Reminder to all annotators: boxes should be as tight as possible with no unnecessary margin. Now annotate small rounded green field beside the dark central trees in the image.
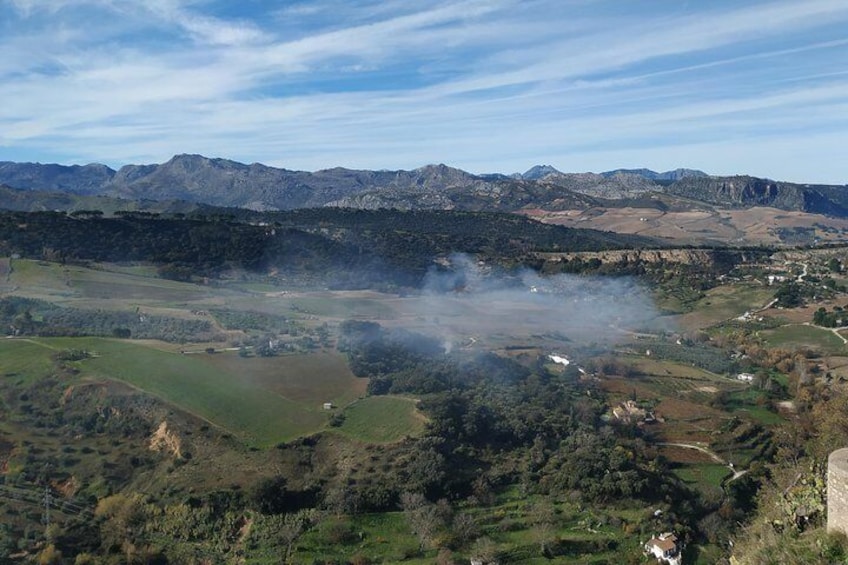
[332,396,425,443]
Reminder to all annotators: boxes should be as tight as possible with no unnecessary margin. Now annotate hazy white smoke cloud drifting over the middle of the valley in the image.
[408,255,663,346]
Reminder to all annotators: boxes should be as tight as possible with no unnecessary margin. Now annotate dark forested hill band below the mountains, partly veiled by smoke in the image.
[0,209,653,288]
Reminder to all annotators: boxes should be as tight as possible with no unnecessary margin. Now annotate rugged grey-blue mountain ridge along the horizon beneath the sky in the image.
[0,155,848,217]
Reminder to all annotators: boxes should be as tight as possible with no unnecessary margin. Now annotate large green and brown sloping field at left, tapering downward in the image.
[0,338,365,447]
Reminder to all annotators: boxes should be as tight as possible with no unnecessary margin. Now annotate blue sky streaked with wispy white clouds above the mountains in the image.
[0,0,848,184]
